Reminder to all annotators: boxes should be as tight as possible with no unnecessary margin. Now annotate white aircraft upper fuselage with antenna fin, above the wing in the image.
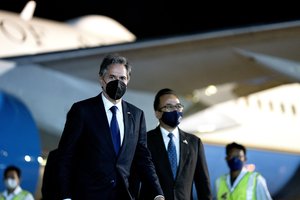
[0,1,136,58]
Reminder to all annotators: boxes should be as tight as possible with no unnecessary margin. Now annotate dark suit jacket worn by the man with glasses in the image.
[140,127,212,200]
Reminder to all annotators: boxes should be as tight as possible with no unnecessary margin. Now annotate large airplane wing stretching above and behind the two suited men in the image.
[9,21,300,103]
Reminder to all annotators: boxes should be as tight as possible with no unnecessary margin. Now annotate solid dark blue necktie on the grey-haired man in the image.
[110,106,121,154]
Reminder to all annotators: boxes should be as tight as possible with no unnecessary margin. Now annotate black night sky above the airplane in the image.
[0,0,300,39]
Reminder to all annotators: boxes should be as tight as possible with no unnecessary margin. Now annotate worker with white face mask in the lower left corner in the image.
[0,166,34,200]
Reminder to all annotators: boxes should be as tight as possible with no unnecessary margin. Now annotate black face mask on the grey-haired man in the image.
[106,80,127,100]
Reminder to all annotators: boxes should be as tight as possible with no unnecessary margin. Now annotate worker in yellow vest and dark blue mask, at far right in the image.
[216,142,272,200]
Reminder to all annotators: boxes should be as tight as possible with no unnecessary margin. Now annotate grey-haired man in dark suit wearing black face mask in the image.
[58,55,164,200]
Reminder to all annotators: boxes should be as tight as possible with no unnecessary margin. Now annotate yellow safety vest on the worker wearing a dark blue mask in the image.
[217,172,259,200]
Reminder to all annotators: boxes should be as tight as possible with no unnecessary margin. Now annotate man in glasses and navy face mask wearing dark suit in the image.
[139,88,212,200]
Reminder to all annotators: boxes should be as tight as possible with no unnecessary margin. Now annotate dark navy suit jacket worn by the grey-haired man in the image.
[58,94,163,200]
